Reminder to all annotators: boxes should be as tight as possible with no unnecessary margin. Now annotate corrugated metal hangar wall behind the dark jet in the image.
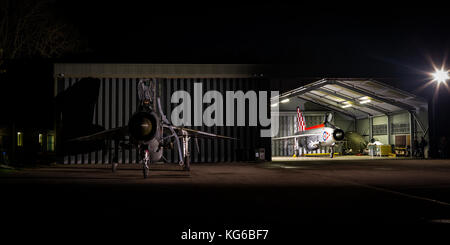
[56,77,271,164]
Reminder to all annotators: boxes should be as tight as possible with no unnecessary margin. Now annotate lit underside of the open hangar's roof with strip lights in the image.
[272,78,428,118]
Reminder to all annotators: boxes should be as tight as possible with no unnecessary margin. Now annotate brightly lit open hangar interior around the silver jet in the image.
[272,78,429,159]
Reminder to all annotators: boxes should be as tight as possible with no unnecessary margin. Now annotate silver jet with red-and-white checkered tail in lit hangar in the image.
[273,107,344,158]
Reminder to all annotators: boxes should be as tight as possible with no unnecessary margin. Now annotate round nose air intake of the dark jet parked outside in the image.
[128,112,159,141]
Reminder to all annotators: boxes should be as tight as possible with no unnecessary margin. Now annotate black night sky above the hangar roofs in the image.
[3,0,450,134]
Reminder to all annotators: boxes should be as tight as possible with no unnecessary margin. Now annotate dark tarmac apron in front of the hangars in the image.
[0,157,450,240]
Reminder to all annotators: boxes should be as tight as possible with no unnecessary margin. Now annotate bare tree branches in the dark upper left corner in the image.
[0,0,80,66]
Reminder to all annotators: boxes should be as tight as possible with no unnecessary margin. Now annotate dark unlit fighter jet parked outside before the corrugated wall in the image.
[69,79,236,178]
